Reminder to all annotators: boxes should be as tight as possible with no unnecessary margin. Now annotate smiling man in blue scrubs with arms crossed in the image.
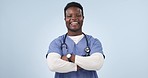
[47,2,104,78]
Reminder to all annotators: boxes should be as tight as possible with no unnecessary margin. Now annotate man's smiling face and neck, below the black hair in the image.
[65,7,84,34]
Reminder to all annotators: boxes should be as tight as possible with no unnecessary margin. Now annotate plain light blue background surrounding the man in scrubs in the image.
[0,0,148,78]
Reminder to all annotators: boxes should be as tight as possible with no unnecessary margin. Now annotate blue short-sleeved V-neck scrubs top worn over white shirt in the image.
[48,34,103,78]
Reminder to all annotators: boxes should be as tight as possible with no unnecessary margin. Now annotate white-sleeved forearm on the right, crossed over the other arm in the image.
[75,53,104,70]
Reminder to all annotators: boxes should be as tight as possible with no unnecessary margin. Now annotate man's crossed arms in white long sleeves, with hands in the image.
[47,52,104,73]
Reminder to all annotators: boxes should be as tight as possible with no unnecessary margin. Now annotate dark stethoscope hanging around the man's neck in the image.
[61,33,91,56]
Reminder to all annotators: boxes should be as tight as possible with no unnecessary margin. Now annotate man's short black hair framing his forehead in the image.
[64,2,84,17]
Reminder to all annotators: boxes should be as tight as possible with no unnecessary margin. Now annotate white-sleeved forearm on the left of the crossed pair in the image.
[47,53,77,73]
